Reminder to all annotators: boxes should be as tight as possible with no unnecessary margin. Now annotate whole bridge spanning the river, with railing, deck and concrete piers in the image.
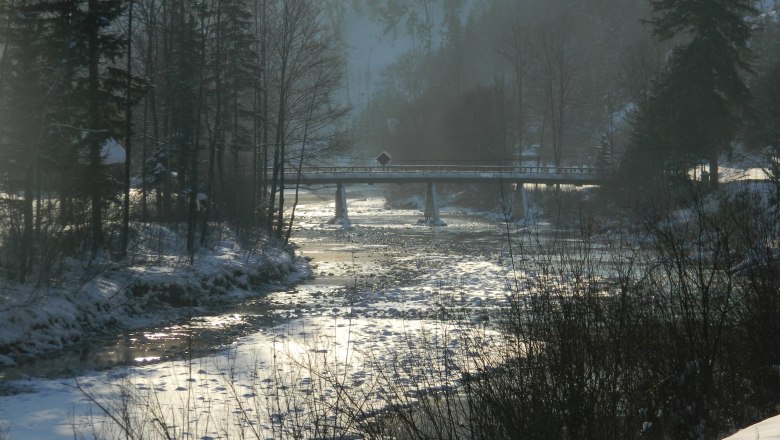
[269,165,614,227]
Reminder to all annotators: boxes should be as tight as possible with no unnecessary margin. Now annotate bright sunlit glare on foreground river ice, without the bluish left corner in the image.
[62,318,501,438]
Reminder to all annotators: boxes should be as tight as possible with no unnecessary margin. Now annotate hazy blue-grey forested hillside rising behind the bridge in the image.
[345,0,778,172]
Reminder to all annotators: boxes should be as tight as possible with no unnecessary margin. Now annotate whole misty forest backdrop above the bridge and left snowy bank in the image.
[0,0,779,251]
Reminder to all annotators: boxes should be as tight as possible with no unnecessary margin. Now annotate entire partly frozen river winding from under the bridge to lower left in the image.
[0,187,556,439]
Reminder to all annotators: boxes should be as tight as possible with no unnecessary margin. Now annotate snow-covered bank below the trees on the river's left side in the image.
[0,225,309,367]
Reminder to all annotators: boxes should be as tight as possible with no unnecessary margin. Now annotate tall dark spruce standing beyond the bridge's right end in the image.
[649,0,755,184]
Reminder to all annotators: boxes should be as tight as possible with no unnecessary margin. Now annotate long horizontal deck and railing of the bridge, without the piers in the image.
[269,165,613,185]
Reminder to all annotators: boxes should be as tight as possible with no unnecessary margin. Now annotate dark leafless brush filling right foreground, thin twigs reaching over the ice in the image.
[71,182,780,440]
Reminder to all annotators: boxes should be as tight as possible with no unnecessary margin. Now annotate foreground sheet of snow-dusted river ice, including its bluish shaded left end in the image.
[0,317,500,440]
